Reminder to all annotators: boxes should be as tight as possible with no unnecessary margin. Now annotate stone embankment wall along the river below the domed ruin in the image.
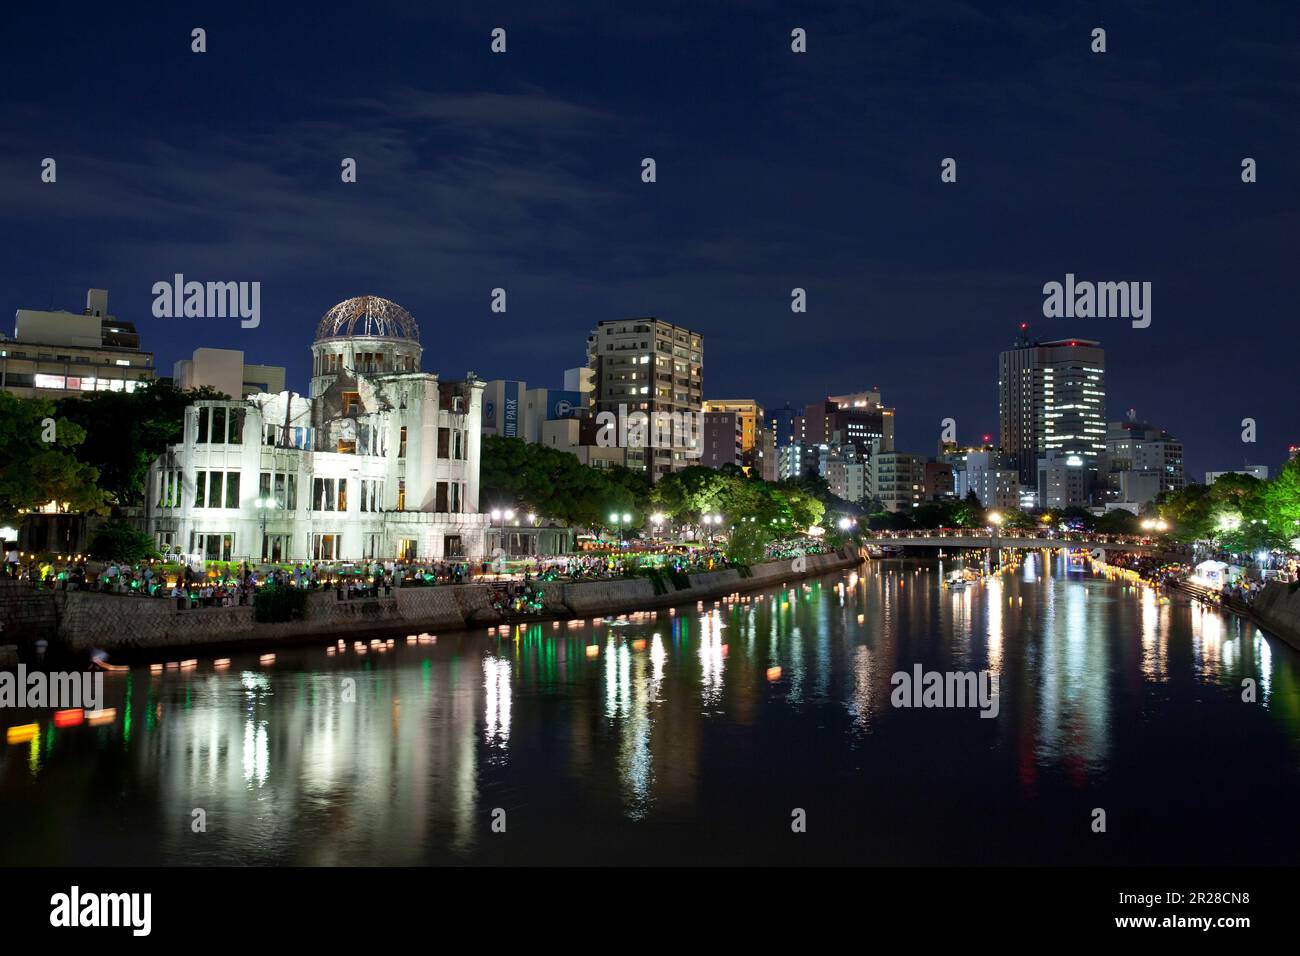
[0,546,861,656]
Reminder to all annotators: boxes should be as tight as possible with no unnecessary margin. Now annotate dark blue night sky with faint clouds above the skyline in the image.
[0,3,1300,479]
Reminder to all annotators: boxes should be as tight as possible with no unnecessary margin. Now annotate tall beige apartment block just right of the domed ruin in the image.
[586,317,705,479]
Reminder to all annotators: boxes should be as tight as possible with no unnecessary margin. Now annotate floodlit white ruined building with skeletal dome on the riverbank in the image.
[146,295,489,561]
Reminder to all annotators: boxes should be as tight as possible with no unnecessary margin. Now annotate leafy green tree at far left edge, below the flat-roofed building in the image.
[0,392,105,520]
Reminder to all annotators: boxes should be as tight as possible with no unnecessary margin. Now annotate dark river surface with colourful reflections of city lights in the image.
[0,554,1300,864]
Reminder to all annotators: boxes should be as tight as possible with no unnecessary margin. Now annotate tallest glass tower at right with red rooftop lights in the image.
[997,334,1106,492]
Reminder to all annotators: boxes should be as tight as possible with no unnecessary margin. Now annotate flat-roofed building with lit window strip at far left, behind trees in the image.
[0,289,153,398]
